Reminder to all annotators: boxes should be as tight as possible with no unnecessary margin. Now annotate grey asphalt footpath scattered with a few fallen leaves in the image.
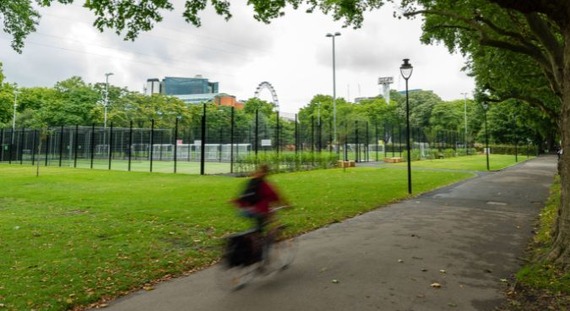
[97,156,556,311]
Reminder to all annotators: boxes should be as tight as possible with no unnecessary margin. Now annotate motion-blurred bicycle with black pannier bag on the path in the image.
[217,206,297,290]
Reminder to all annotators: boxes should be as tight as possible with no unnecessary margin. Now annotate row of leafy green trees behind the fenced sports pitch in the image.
[0,66,556,148]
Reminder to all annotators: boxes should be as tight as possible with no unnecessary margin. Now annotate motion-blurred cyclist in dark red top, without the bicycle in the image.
[234,164,288,232]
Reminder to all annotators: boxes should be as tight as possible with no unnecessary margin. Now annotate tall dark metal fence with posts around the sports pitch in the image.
[0,109,480,174]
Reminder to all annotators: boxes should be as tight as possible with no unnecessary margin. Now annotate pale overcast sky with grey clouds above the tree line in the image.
[0,0,474,112]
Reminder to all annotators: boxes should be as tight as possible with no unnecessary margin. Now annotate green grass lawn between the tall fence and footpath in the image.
[0,157,524,310]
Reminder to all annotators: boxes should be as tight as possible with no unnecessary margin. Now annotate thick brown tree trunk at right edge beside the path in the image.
[548,26,570,271]
